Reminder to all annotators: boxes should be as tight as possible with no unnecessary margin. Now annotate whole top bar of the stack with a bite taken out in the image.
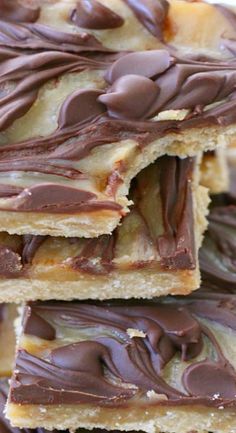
[0,0,236,237]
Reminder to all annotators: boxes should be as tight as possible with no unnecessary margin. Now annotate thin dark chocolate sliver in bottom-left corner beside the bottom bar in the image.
[0,379,69,433]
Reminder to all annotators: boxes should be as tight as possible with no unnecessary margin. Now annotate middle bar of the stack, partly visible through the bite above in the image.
[0,156,209,302]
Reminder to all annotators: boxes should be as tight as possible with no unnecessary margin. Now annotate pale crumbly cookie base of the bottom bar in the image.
[7,403,236,433]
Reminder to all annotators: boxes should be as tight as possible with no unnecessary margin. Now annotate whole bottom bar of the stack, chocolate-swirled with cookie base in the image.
[7,292,236,433]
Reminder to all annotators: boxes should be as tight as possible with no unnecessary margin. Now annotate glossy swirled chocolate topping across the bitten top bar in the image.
[0,0,236,215]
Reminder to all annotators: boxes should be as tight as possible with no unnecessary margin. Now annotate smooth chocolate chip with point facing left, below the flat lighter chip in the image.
[98,75,159,119]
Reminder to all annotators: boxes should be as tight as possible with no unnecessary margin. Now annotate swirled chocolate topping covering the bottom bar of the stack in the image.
[10,292,236,407]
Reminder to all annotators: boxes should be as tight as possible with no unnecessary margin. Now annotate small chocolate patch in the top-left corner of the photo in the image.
[0,0,40,23]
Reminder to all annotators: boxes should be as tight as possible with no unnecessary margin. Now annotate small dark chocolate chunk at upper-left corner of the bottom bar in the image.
[23,306,56,341]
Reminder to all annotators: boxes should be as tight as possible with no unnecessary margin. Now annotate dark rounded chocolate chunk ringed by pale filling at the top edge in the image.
[71,0,124,30]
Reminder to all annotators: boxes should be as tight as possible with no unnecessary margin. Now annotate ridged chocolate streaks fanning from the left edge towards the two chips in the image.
[0,21,112,131]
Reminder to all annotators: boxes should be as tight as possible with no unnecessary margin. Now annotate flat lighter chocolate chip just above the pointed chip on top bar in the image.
[105,50,173,84]
